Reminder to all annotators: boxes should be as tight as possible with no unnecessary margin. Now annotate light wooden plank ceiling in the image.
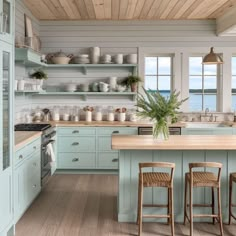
[23,0,236,20]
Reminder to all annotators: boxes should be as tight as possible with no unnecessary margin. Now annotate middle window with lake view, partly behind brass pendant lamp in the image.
[189,56,217,111]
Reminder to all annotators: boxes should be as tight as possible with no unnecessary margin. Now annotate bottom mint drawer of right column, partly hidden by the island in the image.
[98,152,119,169]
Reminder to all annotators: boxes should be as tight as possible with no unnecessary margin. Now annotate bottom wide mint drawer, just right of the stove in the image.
[58,153,96,169]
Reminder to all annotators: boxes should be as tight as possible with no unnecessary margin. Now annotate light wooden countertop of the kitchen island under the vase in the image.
[112,135,236,150]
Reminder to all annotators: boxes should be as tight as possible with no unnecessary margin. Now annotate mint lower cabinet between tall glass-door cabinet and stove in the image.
[14,138,41,223]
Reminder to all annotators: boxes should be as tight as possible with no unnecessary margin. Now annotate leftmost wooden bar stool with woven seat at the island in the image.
[137,162,175,236]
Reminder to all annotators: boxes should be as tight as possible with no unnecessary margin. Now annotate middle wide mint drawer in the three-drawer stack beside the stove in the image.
[58,136,96,152]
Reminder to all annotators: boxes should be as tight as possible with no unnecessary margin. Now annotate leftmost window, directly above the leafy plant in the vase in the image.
[145,55,173,96]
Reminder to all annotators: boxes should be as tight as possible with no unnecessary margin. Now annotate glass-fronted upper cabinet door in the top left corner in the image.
[0,0,14,44]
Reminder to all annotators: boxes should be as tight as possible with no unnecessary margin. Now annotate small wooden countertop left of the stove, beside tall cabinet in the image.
[15,131,42,150]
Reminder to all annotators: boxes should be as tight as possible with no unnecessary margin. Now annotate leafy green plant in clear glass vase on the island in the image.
[136,88,188,139]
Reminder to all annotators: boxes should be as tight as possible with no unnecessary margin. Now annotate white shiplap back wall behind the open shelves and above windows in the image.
[16,0,236,121]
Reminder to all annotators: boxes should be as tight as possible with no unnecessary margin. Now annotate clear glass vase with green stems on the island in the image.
[152,118,169,140]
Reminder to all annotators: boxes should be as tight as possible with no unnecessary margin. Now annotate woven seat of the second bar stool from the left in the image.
[186,171,219,187]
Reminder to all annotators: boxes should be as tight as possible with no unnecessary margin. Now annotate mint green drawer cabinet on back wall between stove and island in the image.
[57,127,138,170]
